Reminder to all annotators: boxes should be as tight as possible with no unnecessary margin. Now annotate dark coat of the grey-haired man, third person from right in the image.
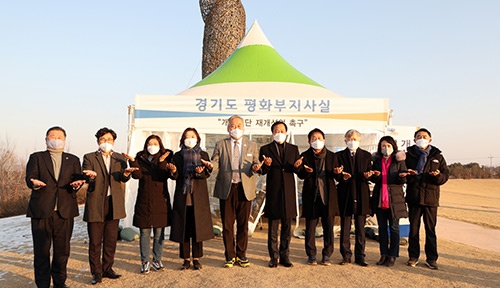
[336,148,372,216]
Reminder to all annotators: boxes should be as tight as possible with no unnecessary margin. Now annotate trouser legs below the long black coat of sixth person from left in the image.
[267,218,292,260]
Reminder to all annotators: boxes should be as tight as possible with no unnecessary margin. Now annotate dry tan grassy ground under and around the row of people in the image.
[0,180,500,288]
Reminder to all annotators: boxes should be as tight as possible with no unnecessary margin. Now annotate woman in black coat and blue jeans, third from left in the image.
[125,135,177,274]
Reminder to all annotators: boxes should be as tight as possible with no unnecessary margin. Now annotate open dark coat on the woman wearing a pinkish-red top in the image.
[370,155,408,219]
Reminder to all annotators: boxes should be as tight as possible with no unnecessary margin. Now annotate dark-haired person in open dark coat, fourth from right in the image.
[297,128,342,266]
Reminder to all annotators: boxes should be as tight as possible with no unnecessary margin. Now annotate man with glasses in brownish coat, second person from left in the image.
[83,128,138,285]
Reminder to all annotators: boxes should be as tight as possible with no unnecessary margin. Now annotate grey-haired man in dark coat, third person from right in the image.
[336,129,373,267]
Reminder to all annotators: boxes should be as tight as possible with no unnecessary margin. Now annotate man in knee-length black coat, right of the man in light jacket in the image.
[259,121,301,268]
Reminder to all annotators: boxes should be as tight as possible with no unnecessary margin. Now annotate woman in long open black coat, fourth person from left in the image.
[170,128,214,270]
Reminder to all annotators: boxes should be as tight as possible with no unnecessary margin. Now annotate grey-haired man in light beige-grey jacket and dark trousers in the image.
[212,115,260,268]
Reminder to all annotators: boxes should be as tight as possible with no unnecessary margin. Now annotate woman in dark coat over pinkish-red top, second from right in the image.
[370,136,408,267]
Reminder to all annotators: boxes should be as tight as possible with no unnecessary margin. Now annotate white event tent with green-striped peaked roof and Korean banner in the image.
[124,22,415,230]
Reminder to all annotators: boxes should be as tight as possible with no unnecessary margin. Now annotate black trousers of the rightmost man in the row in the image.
[408,205,438,261]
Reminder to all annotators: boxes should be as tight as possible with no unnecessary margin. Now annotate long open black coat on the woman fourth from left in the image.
[170,151,214,243]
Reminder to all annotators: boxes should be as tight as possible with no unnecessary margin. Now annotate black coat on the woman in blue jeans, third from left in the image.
[130,150,177,228]
